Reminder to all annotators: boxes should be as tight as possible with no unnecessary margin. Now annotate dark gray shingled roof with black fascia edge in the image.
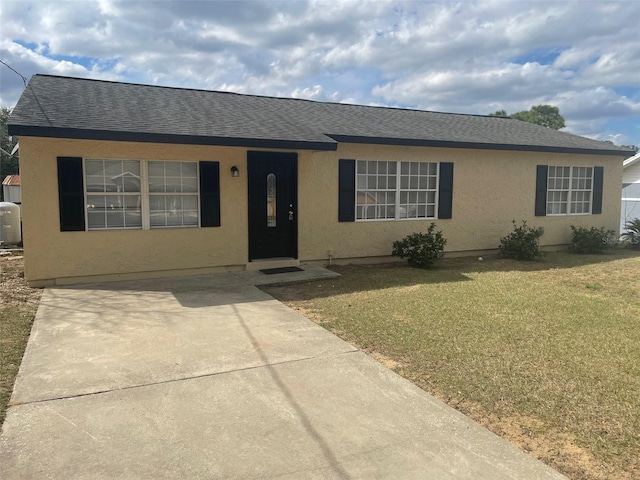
[9,75,633,157]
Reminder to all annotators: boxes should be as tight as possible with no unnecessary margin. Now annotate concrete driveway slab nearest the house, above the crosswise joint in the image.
[11,285,354,405]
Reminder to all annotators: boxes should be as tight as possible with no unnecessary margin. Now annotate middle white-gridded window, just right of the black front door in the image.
[356,160,438,220]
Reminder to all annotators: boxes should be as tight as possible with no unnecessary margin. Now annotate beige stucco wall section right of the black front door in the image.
[299,144,622,260]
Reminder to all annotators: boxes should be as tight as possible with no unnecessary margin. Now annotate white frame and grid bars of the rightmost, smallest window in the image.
[545,165,595,217]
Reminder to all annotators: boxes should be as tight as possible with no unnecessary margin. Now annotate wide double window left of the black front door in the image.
[84,160,199,230]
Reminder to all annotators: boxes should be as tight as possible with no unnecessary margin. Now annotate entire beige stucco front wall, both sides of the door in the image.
[20,137,622,284]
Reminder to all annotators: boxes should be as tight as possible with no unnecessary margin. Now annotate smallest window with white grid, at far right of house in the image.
[547,166,593,215]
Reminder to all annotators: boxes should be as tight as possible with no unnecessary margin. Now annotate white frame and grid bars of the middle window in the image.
[354,160,440,222]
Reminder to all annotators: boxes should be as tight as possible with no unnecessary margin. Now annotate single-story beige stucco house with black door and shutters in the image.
[9,75,632,286]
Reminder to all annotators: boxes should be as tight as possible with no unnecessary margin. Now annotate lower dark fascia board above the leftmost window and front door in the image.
[9,124,338,151]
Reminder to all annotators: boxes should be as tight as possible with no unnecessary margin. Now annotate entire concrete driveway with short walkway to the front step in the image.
[0,266,565,480]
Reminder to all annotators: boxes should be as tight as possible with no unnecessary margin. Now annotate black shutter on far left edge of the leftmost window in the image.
[58,157,85,232]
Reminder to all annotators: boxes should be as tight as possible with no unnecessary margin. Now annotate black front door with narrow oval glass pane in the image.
[247,152,298,260]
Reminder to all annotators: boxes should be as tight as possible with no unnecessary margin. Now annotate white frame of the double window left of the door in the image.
[82,158,201,232]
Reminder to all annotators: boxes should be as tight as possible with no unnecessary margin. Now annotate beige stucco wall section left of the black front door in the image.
[20,137,248,282]
